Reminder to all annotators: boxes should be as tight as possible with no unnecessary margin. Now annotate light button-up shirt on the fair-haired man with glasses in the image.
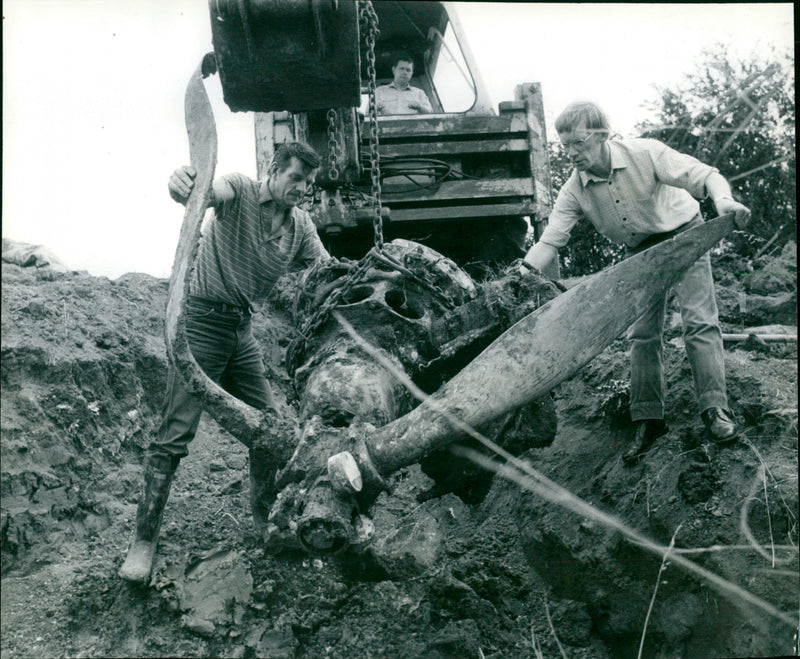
[540,138,717,248]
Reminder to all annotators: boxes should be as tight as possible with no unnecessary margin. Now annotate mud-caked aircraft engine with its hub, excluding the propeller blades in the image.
[260,240,557,551]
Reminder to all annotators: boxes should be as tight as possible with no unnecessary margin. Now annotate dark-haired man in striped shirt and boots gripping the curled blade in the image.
[120,142,330,583]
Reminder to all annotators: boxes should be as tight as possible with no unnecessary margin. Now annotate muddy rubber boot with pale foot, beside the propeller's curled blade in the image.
[119,456,178,584]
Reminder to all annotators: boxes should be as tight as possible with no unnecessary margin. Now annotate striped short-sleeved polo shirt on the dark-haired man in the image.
[189,174,330,306]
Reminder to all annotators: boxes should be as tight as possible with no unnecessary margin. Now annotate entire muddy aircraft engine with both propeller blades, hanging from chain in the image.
[166,51,733,551]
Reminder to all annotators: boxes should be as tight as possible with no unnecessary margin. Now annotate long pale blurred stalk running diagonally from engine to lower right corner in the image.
[332,311,796,629]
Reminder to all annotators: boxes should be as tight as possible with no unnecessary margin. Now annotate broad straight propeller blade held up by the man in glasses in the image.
[367,214,734,473]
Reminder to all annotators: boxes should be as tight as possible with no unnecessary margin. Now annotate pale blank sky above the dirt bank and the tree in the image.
[2,0,794,278]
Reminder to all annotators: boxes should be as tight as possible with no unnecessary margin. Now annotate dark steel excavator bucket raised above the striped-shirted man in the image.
[209,0,361,112]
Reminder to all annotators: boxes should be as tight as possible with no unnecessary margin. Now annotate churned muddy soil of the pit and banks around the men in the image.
[0,245,800,659]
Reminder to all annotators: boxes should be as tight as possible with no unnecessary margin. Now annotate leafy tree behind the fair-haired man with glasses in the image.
[550,44,797,276]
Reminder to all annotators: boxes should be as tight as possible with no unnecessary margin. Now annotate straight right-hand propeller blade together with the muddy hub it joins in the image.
[262,216,733,550]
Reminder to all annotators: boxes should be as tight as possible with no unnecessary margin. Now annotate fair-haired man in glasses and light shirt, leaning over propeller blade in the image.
[524,102,750,464]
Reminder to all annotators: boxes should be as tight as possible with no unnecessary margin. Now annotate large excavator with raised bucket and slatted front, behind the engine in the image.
[209,0,552,275]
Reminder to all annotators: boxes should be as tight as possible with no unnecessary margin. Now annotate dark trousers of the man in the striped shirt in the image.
[149,297,273,462]
